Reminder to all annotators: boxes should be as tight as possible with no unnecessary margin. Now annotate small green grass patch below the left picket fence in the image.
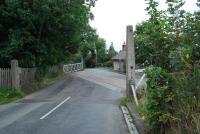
[0,88,25,105]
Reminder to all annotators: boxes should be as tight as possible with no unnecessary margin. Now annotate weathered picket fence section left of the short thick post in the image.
[0,68,12,88]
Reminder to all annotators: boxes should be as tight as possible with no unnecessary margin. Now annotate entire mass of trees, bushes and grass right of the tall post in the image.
[134,0,200,134]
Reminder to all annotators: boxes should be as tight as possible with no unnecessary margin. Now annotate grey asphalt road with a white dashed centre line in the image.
[0,69,128,134]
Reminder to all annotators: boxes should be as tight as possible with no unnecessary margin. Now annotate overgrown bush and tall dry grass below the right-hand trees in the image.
[145,65,200,134]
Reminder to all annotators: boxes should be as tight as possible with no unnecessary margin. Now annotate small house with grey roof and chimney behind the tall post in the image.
[112,43,126,73]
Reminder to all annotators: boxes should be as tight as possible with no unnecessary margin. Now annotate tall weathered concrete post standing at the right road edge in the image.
[126,26,135,97]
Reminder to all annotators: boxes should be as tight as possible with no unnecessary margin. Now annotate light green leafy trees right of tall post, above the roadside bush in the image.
[134,0,200,71]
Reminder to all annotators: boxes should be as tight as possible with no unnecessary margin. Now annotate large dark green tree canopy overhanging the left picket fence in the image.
[0,0,95,67]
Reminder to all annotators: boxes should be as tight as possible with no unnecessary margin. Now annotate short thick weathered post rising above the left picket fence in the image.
[11,60,20,90]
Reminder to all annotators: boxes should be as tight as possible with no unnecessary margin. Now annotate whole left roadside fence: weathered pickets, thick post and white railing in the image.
[0,60,83,89]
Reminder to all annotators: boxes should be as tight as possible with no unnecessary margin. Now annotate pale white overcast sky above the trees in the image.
[90,0,197,51]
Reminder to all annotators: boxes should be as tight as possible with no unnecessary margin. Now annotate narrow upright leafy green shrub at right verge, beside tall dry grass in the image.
[145,66,173,134]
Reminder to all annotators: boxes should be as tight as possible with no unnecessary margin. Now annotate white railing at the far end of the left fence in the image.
[63,63,83,73]
